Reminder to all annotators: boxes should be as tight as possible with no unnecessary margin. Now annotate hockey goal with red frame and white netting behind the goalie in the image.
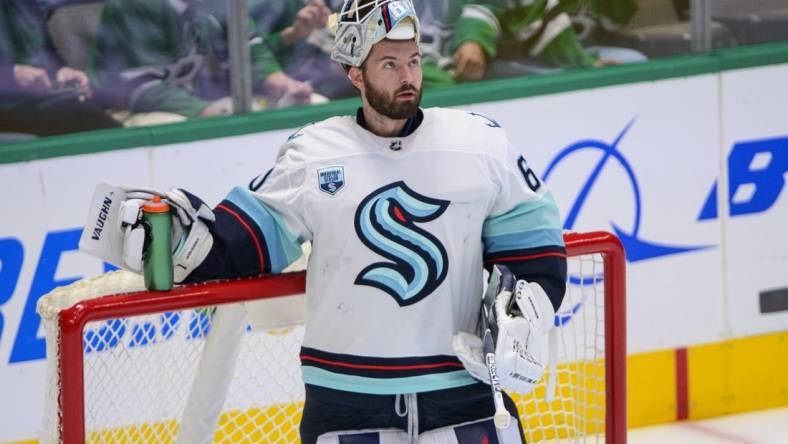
[37,232,626,444]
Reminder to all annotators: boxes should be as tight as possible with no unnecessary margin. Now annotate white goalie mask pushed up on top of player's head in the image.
[331,0,419,66]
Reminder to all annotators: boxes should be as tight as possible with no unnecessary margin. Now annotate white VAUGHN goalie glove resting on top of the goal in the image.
[79,183,215,283]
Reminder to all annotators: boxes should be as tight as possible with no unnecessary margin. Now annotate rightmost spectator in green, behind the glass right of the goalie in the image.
[492,0,646,76]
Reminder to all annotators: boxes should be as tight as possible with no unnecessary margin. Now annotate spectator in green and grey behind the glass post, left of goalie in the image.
[91,0,318,122]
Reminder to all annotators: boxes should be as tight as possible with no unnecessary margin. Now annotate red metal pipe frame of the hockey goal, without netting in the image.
[58,231,627,444]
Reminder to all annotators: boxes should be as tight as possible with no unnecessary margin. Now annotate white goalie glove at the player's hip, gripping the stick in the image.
[452,266,555,394]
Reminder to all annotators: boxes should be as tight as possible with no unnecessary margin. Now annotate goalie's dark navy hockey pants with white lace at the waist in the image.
[300,383,525,444]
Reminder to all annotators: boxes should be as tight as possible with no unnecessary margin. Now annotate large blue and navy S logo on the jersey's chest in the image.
[355,182,450,307]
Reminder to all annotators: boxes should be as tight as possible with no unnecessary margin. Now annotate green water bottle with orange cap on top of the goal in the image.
[142,196,172,291]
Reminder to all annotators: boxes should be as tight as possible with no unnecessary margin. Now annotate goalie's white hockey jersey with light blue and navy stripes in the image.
[209,108,565,394]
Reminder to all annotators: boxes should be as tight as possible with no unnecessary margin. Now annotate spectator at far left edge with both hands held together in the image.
[0,0,119,139]
